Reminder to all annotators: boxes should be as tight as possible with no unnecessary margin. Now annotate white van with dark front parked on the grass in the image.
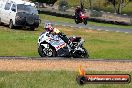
[0,0,40,30]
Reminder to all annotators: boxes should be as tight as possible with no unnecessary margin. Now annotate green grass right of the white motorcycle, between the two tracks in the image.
[60,26,132,59]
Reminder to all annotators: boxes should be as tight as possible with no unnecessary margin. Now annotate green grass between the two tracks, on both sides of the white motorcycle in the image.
[0,26,132,59]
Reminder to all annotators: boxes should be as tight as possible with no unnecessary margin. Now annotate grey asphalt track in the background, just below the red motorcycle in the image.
[43,20,132,33]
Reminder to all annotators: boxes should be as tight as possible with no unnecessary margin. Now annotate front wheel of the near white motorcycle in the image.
[38,45,56,57]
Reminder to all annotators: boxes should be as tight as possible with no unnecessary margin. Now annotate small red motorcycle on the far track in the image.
[75,12,88,25]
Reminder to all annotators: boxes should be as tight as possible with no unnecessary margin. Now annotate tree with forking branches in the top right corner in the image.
[107,0,132,14]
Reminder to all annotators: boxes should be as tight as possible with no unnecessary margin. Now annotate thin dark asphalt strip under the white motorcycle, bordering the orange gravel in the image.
[0,56,132,62]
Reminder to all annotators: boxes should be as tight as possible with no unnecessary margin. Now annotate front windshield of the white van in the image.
[17,4,38,14]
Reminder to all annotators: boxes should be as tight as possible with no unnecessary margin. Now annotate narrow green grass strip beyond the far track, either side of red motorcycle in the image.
[40,14,132,30]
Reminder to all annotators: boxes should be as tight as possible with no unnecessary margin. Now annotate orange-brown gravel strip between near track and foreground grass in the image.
[0,59,132,71]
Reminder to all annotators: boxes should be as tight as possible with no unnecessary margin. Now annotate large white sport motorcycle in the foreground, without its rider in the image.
[38,32,89,58]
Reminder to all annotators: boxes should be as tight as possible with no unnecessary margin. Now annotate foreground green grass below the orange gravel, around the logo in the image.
[0,71,132,88]
